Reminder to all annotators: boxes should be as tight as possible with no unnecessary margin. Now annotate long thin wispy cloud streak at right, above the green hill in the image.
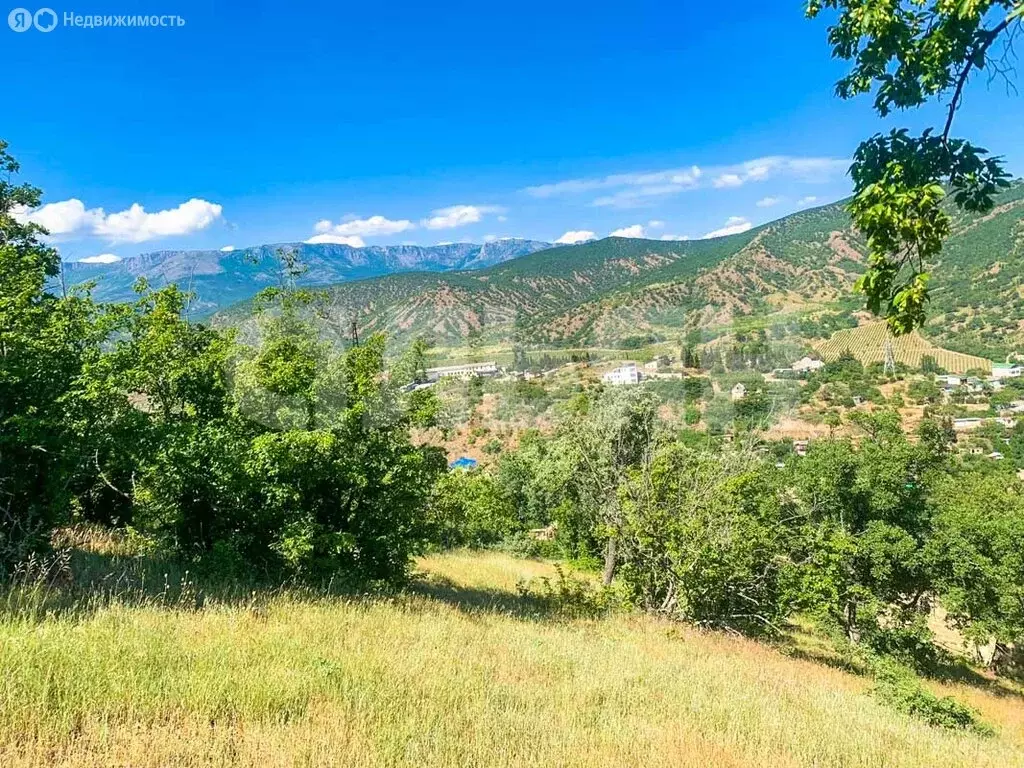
[523,155,849,208]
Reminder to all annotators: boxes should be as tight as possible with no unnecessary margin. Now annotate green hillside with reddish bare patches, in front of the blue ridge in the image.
[218,182,1024,356]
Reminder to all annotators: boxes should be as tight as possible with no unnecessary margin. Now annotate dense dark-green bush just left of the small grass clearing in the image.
[246,428,443,584]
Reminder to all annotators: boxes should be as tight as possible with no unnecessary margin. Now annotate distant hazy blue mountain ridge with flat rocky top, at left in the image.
[65,238,552,313]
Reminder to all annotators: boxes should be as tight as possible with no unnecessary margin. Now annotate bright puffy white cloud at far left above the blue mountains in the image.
[14,198,223,243]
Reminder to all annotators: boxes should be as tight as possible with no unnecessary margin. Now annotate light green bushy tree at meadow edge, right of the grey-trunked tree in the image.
[622,443,793,633]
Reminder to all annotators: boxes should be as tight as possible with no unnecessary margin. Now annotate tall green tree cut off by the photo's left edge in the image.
[0,140,105,572]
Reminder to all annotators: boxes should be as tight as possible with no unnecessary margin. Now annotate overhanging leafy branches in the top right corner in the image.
[807,0,1024,335]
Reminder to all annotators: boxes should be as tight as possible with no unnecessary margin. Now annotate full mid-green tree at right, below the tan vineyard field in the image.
[793,423,931,641]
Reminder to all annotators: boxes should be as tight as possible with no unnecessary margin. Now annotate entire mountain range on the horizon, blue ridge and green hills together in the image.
[69,181,1024,359]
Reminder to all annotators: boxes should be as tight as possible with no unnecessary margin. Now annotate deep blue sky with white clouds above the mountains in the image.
[8,0,1024,258]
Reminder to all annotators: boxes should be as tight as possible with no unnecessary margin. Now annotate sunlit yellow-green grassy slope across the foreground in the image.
[0,553,1024,768]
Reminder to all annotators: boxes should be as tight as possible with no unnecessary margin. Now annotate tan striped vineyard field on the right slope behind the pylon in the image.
[815,323,992,373]
